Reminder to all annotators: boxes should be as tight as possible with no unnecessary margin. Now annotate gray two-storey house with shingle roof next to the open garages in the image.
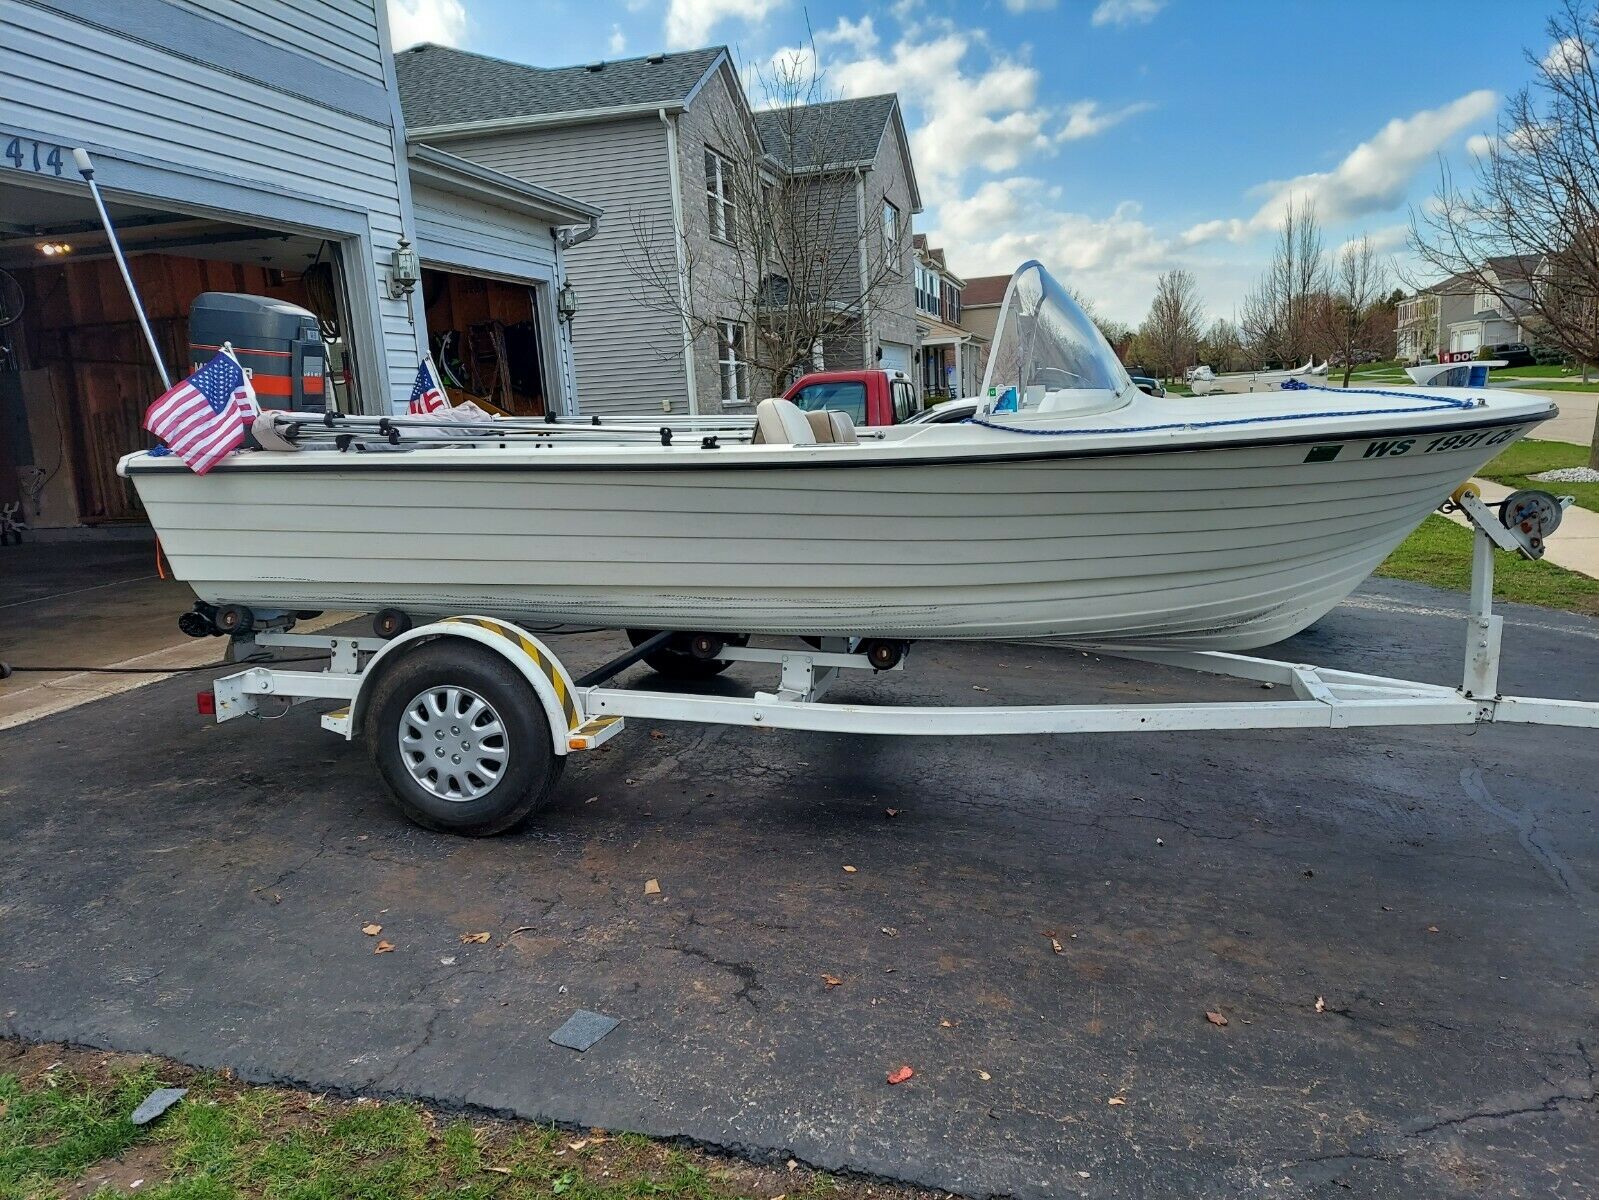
[395,45,921,413]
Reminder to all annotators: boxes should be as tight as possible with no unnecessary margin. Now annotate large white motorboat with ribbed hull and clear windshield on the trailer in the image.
[118,262,1556,650]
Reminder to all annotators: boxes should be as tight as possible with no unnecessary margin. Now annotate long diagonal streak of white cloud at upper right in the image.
[1183,90,1497,245]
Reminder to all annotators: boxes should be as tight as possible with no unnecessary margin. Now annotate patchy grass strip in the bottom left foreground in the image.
[0,1042,924,1200]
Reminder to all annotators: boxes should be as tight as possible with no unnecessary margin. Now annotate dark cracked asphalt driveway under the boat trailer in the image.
[0,582,1599,1197]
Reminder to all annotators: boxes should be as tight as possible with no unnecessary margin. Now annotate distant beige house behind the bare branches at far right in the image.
[1396,254,1543,362]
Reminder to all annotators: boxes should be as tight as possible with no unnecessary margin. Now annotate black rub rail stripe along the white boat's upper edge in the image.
[128,405,1559,475]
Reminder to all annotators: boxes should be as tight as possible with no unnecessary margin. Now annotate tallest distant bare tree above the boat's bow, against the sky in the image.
[1239,197,1327,366]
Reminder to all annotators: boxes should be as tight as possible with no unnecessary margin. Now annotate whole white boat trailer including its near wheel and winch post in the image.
[200,485,1599,835]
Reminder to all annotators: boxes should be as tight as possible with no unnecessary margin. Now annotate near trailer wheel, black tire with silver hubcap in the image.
[363,649,566,837]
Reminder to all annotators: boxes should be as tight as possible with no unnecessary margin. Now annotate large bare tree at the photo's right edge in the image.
[1410,0,1599,466]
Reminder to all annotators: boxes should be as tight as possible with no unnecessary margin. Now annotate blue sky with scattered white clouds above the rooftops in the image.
[389,0,1548,322]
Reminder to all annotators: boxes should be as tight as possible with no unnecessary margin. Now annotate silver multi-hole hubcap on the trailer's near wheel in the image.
[400,686,510,802]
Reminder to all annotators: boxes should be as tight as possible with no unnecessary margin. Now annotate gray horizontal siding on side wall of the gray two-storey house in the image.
[438,117,694,416]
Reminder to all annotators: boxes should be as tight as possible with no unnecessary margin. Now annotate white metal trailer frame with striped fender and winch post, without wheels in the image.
[211,488,1599,838]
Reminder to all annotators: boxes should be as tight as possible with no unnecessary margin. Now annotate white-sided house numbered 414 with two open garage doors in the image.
[0,0,600,528]
